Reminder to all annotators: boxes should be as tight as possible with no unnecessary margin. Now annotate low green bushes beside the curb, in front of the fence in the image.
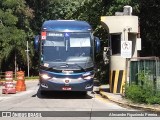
[125,70,160,104]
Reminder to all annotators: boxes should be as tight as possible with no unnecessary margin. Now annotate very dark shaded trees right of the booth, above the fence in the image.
[140,0,160,56]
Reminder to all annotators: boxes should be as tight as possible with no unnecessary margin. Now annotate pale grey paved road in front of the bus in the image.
[0,81,159,120]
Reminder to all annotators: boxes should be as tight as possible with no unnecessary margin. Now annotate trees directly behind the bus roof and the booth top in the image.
[26,0,139,79]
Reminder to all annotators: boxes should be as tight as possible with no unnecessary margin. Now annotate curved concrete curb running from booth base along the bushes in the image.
[99,89,160,112]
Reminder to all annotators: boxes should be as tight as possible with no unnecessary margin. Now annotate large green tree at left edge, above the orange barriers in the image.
[0,0,33,73]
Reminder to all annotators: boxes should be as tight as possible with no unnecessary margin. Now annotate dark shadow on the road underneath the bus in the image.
[32,90,93,99]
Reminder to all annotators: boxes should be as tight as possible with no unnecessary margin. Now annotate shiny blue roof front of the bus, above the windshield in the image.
[42,20,92,32]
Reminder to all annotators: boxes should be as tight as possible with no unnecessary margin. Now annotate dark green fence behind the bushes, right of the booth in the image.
[129,57,160,91]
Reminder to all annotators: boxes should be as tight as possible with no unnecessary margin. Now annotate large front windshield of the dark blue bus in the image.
[42,32,93,67]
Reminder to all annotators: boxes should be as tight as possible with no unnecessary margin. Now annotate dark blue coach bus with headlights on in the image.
[34,20,100,94]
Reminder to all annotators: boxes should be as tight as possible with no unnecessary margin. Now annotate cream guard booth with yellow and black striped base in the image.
[101,6,141,93]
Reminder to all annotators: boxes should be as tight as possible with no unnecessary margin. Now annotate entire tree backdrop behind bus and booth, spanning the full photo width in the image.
[0,0,160,79]
